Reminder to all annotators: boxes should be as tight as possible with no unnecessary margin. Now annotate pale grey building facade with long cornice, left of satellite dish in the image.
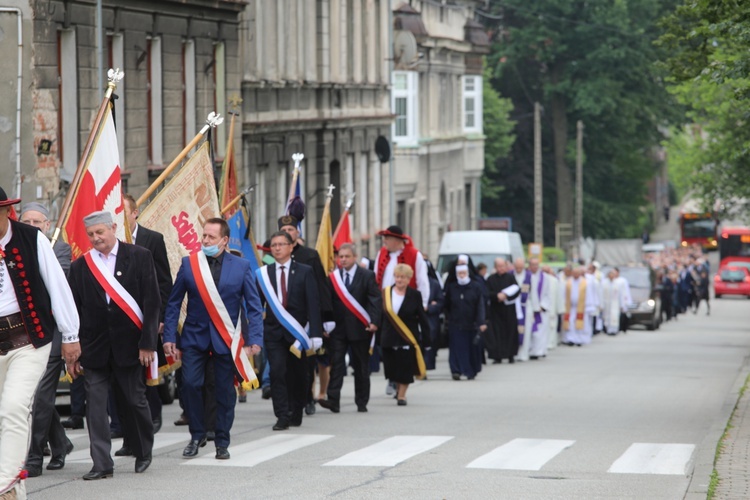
[241,0,393,255]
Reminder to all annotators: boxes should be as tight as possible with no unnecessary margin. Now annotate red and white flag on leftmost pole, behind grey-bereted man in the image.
[63,104,125,259]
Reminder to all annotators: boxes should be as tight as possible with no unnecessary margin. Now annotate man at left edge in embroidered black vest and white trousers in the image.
[0,188,81,498]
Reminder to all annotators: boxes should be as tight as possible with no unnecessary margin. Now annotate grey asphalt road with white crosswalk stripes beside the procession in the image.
[27,299,750,500]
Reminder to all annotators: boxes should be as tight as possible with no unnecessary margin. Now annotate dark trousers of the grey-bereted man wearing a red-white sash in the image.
[85,363,154,471]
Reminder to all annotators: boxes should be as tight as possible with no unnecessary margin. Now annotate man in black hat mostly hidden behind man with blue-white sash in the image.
[278,215,336,415]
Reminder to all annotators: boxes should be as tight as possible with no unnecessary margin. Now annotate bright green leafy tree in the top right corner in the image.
[659,0,750,216]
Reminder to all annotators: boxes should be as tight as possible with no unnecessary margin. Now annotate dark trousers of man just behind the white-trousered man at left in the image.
[26,332,68,467]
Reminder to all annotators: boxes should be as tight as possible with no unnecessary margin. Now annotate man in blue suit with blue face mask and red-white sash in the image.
[164,218,263,460]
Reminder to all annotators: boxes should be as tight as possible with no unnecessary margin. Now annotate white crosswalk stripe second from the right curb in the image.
[466,439,575,470]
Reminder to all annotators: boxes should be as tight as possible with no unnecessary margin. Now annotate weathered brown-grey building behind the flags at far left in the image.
[0,0,245,217]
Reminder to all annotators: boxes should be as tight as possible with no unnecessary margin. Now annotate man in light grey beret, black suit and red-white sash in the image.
[68,211,161,480]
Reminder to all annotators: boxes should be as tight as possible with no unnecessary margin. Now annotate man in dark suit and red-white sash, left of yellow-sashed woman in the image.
[318,243,382,413]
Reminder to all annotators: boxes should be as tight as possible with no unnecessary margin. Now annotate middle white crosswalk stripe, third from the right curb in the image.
[323,436,453,467]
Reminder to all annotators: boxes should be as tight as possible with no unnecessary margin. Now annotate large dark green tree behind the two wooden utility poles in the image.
[488,0,678,241]
